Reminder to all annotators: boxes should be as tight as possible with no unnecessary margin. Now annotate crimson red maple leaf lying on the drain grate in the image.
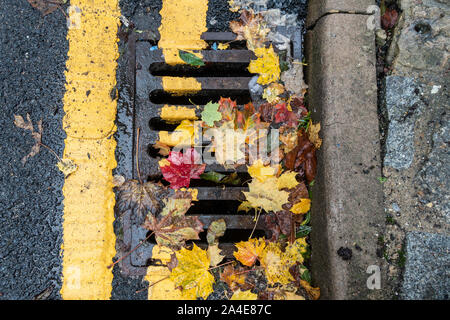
[160,148,206,189]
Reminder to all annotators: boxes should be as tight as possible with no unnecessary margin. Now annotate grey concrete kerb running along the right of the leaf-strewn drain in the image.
[305,0,385,299]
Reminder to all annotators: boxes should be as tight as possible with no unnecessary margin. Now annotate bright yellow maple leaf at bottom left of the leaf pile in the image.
[170,243,215,299]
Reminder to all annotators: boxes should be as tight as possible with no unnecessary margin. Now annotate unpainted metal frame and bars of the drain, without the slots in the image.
[121,27,302,275]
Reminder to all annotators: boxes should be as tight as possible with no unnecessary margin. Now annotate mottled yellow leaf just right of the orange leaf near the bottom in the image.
[260,242,294,285]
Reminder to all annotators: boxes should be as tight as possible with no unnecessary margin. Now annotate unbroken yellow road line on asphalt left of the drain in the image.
[61,0,120,299]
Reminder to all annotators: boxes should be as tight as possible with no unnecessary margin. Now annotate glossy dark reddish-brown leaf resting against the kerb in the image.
[285,129,317,183]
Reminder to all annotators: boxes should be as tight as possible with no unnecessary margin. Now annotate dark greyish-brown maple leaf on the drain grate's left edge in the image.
[118,180,165,218]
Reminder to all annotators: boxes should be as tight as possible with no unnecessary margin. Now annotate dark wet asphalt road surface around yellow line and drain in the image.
[0,0,306,299]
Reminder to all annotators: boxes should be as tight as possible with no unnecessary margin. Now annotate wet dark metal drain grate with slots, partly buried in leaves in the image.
[122,28,301,275]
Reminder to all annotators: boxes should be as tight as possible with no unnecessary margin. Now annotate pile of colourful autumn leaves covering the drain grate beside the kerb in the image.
[114,10,322,300]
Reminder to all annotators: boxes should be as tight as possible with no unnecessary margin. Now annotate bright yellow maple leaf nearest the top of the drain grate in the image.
[248,45,281,85]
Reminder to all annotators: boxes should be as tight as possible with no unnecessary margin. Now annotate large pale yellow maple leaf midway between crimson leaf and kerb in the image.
[243,177,289,212]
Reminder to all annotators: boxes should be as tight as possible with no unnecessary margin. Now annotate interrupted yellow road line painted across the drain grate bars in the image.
[149,0,208,300]
